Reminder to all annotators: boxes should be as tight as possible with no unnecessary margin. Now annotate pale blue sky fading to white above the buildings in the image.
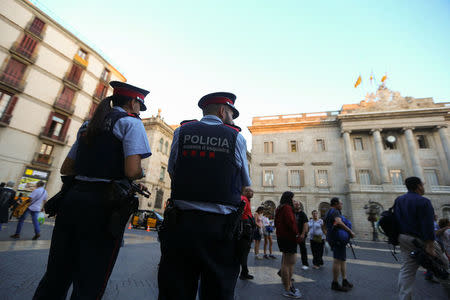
[32,0,450,148]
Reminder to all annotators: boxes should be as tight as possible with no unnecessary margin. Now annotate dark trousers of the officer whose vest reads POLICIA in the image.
[158,211,241,300]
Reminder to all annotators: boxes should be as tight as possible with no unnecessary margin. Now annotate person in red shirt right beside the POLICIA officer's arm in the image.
[239,187,255,280]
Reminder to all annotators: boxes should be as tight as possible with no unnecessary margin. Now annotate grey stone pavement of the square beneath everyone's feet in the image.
[0,221,448,300]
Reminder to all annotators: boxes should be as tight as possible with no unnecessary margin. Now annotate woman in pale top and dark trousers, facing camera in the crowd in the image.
[308,210,326,269]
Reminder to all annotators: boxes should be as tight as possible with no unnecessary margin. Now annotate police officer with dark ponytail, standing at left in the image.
[33,81,151,300]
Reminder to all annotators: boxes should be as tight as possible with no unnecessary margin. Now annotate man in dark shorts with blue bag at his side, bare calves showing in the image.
[325,197,355,292]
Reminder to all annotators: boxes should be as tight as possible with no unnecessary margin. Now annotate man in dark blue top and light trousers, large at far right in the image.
[394,177,436,299]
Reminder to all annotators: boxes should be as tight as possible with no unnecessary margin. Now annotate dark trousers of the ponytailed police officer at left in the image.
[33,182,125,300]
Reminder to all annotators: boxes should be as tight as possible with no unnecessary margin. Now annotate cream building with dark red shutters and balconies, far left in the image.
[0,0,126,195]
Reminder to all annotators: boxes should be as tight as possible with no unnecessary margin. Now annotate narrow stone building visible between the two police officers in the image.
[140,110,174,213]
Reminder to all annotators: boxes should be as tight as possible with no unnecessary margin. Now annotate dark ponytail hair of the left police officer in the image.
[86,95,131,144]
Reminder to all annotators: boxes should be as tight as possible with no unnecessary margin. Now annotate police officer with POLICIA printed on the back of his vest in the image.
[158,92,251,300]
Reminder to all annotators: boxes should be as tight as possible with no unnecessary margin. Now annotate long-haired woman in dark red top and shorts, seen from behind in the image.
[275,191,302,298]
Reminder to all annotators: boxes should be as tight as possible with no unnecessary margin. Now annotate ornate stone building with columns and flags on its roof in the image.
[249,86,450,238]
